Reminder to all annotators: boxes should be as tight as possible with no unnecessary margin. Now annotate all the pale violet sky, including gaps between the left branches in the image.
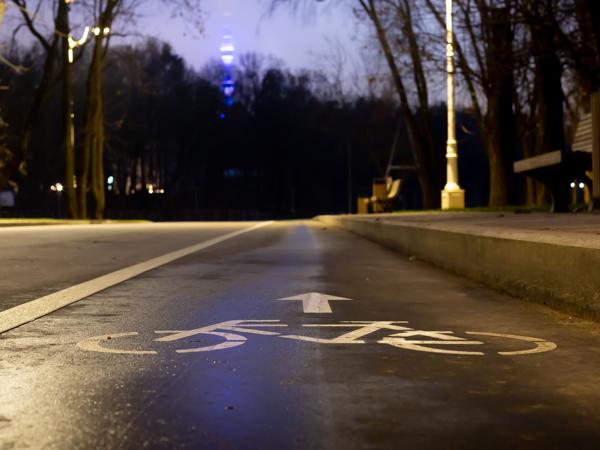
[0,0,361,78]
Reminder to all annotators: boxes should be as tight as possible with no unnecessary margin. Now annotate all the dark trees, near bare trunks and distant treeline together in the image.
[0,0,600,218]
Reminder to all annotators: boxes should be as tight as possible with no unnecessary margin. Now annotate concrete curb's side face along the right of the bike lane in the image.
[317,216,600,321]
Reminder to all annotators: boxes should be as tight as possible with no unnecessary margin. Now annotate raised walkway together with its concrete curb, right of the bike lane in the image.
[319,212,600,320]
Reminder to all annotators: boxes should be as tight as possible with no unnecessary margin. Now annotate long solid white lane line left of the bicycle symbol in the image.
[0,221,273,334]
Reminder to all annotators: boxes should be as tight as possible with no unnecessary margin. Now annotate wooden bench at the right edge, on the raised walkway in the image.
[513,114,592,212]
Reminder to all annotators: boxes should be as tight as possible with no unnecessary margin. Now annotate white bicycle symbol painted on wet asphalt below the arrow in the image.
[77,320,557,356]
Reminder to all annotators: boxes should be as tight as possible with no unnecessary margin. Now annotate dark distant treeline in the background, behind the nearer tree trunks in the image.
[0,40,487,219]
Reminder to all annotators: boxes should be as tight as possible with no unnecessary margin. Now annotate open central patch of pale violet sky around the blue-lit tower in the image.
[138,0,359,69]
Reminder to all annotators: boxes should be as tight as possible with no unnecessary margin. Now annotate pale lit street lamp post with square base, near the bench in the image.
[442,0,465,209]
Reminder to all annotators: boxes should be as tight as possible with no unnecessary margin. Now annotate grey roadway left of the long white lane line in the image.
[0,222,255,311]
